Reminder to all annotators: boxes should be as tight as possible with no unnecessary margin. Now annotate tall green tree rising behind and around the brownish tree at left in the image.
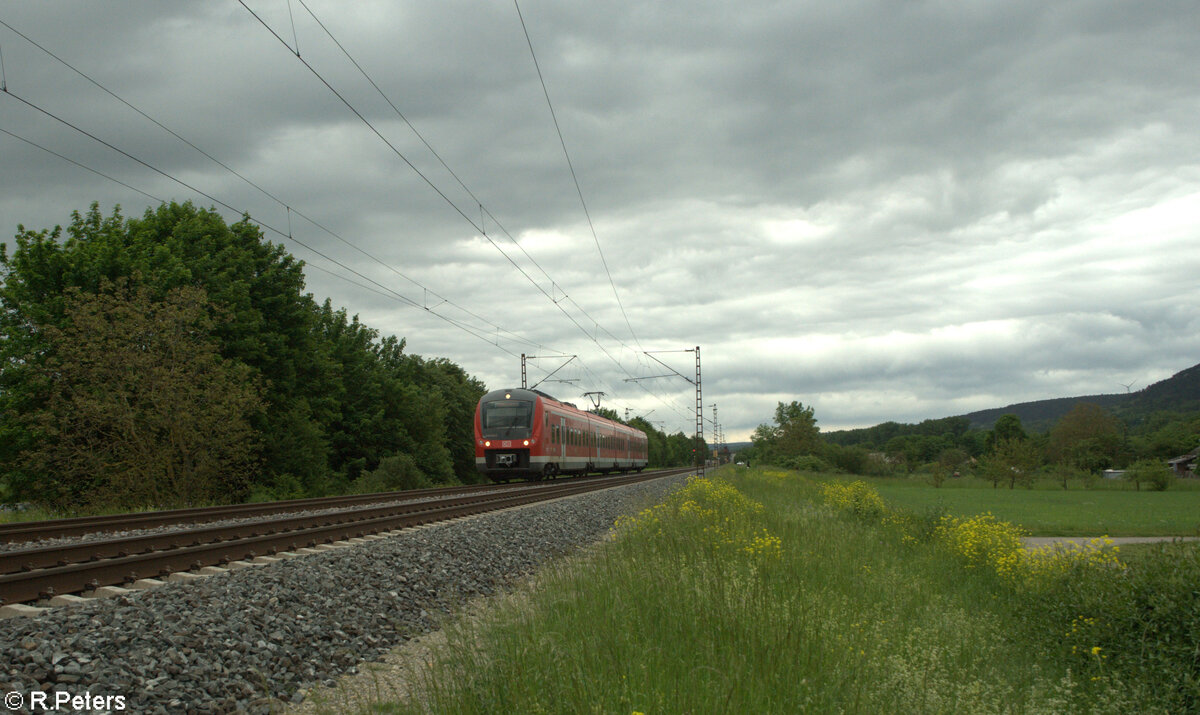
[0,203,338,491]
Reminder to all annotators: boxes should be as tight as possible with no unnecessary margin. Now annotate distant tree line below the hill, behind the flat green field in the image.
[738,393,1200,488]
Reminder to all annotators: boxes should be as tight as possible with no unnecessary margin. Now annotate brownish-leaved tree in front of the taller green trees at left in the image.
[14,281,262,509]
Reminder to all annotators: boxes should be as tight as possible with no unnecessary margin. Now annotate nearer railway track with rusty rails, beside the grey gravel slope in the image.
[0,469,690,603]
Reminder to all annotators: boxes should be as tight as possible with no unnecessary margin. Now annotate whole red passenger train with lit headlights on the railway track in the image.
[475,387,647,481]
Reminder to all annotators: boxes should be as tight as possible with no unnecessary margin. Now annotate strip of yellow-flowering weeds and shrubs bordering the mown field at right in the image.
[821,472,1200,713]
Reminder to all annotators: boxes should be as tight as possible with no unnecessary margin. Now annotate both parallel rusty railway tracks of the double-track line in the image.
[0,469,688,606]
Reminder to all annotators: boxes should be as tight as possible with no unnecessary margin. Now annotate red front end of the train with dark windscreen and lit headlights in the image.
[475,389,541,481]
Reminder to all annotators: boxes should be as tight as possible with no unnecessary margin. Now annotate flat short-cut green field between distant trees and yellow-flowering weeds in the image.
[869,479,1200,536]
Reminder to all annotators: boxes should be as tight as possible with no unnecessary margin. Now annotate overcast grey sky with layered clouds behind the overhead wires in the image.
[0,0,1200,440]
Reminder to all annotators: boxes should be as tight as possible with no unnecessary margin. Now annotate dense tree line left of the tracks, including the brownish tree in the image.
[0,203,484,509]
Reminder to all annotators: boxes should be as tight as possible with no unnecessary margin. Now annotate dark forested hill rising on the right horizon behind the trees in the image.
[961,365,1200,432]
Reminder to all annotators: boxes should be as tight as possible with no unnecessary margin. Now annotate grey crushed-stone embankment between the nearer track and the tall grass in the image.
[0,476,684,714]
